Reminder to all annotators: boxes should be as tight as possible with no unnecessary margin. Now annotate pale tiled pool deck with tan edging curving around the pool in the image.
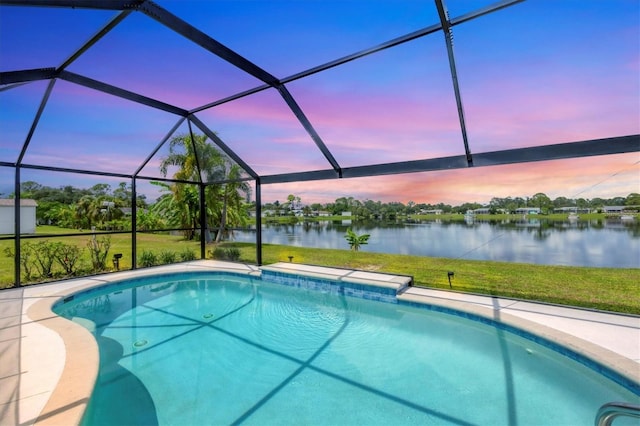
[0,261,640,425]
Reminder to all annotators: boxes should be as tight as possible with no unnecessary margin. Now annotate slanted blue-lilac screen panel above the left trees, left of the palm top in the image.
[24,81,176,174]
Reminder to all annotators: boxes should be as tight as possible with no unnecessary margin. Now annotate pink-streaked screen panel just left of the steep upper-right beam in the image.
[288,33,464,167]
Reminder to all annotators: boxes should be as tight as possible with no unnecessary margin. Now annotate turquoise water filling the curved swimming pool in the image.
[55,273,640,425]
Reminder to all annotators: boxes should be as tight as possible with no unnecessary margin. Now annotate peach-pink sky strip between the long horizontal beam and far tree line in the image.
[263,153,640,205]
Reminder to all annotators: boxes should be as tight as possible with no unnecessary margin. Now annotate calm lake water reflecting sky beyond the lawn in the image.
[234,218,640,268]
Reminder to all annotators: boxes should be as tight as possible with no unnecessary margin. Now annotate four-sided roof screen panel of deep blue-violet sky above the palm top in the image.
[69,13,262,109]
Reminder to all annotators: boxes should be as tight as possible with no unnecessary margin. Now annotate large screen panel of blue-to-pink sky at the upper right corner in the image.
[453,1,640,152]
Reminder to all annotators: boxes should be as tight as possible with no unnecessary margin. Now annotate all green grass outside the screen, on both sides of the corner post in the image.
[0,227,640,315]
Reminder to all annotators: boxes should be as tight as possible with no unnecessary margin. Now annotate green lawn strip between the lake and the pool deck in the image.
[225,243,640,315]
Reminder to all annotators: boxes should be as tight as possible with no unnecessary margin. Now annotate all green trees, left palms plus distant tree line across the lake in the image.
[6,134,640,236]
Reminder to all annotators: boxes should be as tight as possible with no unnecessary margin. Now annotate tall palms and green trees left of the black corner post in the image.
[10,135,251,241]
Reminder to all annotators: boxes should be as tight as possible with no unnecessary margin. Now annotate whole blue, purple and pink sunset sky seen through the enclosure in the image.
[0,0,640,205]
